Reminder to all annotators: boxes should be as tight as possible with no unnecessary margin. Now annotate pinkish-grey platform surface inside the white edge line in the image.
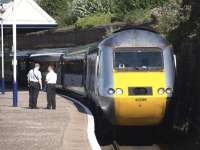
[0,92,91,150]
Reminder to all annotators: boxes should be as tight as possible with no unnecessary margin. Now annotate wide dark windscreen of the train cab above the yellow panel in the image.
[114,49,163,70]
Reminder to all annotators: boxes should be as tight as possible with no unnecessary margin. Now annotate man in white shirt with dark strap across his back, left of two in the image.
[27,63,42,109]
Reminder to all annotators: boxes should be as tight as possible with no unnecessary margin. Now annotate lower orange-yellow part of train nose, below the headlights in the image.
[115,96,166,125]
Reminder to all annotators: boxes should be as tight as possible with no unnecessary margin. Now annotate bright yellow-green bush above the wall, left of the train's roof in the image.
[75,13,111,29]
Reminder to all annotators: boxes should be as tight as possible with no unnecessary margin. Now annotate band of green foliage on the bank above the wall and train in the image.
[40,0,190,34]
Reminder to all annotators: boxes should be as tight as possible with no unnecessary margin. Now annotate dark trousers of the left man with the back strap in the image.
[29,82,40,108]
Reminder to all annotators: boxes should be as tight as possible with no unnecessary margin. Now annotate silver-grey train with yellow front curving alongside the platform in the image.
[28,29,175,126]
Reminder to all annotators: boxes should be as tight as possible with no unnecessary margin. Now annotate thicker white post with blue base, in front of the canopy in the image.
[13,0,18,107]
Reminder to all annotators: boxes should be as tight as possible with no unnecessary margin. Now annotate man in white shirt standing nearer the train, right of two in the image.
[46,65,57,109]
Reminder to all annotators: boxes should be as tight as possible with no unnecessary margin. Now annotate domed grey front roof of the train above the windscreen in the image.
[99,29,171,49]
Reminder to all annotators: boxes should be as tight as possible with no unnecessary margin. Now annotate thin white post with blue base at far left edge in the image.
[0,3,6,94]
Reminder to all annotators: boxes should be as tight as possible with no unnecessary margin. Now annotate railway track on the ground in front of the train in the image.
[102,141,163,150]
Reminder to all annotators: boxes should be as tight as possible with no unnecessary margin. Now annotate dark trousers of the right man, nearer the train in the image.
[47,84,56,109]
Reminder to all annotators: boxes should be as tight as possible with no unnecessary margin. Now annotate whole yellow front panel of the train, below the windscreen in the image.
[114,72,167,125]
